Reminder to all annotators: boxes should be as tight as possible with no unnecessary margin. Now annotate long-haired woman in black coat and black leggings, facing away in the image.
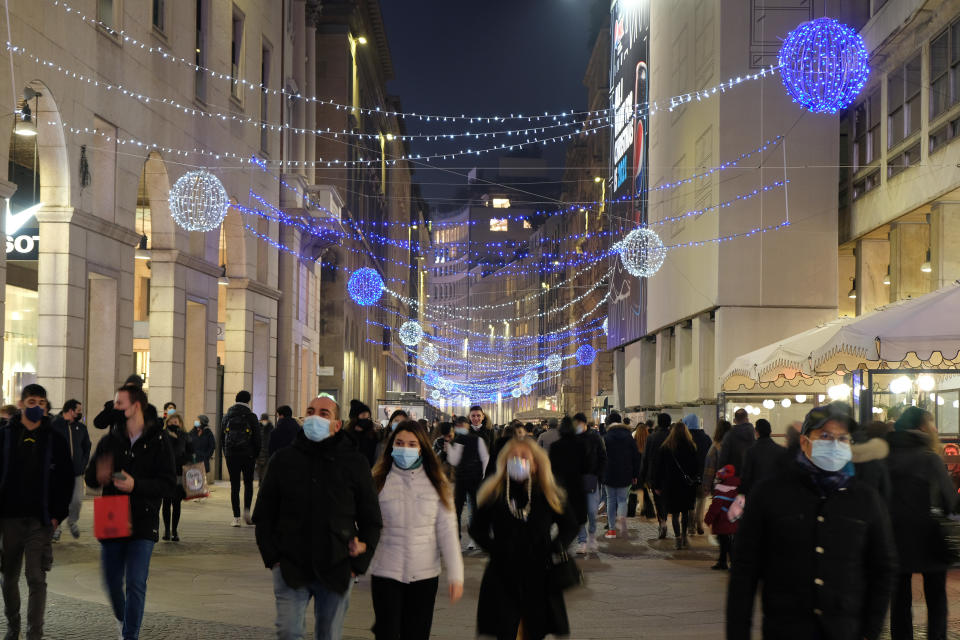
[653,422,701,549]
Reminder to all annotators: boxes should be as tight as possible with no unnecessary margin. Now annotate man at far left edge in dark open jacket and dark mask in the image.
[0,384,73,640]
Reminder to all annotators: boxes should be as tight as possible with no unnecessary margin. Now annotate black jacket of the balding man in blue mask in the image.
[253,431,383,593]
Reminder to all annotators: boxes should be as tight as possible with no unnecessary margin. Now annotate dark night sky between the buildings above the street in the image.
[380,0,609,209]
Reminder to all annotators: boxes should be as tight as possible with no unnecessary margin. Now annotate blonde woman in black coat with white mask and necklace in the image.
[470,439,577,640]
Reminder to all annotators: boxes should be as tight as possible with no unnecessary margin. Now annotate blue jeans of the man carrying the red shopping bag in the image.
[100,538,154,640]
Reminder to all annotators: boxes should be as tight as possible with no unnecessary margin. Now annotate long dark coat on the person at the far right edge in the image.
[887,431,957,573]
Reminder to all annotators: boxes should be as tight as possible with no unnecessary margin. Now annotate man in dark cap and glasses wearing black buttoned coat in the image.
[727,402,896,640]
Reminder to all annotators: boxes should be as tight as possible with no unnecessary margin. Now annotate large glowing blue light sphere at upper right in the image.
[778,18,870,113]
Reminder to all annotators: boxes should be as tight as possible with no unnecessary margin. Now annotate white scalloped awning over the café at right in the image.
[721,283,960,391]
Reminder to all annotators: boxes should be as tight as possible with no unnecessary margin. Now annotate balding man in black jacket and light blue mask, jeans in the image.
[253,395,383,638]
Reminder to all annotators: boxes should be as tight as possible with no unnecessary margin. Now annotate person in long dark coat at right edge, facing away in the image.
[887,407,957,640]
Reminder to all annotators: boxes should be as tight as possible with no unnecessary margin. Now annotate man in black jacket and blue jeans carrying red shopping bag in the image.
[84,385,177,640]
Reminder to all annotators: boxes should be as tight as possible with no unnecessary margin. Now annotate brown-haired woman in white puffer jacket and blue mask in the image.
[370,421,463,640]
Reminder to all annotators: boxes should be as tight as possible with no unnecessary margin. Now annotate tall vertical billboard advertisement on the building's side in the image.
[607,0,650,349]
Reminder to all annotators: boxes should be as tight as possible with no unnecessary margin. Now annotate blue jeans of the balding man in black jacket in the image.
[273,566,353,640]
